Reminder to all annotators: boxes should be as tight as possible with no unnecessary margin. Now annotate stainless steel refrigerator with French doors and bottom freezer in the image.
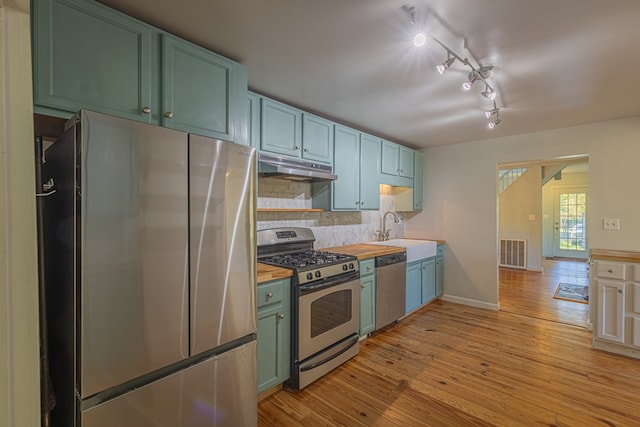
[42,111,257,427]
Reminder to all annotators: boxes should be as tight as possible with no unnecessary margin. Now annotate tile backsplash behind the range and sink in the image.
[257,177,404,249]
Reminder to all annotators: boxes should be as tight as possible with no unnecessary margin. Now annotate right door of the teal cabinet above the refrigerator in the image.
[161,34,247,143]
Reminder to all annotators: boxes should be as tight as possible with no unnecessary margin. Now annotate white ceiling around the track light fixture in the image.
[101,0,640,148]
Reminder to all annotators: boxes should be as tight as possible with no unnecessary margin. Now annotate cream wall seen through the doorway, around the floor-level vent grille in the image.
[498,165,542,271]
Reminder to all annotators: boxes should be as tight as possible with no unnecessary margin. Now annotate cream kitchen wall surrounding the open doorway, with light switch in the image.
[405,117,640,308]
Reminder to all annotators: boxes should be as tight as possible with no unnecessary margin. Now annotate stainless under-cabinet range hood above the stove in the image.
[258,153,338,182]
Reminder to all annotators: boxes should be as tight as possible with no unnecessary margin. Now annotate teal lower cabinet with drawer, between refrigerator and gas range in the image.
[258,279,291,393]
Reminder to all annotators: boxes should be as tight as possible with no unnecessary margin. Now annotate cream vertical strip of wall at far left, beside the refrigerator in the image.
[0,0,40,427]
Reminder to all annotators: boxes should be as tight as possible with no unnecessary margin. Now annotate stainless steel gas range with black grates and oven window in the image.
[257,227,360,390]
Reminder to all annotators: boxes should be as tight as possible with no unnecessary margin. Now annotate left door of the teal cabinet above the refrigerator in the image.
[32,0,152,122]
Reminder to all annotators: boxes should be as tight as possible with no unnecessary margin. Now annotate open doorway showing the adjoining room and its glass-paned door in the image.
[498,158,589,327]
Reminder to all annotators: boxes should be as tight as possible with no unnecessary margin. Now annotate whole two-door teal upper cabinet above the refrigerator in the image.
[32,0,248,144]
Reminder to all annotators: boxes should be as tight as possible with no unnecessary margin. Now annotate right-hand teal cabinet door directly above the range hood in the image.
[302,113,333,163]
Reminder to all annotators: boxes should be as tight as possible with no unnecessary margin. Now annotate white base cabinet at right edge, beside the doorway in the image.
[590,251,640,358]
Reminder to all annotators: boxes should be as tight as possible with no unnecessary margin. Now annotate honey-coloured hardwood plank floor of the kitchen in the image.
[259,260,640,427]
